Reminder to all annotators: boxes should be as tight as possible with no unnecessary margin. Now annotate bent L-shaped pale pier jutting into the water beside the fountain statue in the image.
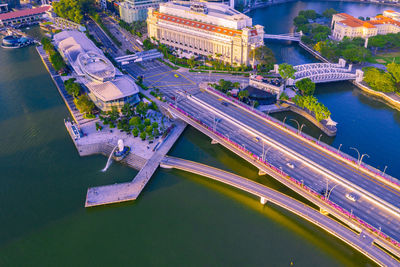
[85,120,187,207]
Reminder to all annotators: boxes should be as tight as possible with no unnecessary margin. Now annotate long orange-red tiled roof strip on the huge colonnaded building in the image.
[154,12,242,36]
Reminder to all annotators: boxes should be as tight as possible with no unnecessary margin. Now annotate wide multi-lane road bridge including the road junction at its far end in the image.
[126,59,400,258]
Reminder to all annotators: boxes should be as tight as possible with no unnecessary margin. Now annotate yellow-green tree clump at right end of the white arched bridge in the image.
[363,63,400,93]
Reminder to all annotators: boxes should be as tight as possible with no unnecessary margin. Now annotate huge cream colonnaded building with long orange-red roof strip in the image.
[147,1,264,65]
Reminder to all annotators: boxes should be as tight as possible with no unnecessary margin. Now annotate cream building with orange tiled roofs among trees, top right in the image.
[331,10,400,40]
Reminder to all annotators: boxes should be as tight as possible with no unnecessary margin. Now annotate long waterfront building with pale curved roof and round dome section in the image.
[54,31,140,111]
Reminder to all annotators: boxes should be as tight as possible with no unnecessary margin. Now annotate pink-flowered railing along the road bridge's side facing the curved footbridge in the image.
[169,103,400,251]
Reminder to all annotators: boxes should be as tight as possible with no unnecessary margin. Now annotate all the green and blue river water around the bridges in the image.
[0,2,400,266]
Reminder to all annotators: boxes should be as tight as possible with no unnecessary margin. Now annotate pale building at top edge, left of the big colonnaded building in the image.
[119,0,164,23]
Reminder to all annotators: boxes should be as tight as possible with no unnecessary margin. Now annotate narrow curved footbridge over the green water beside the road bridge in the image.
[160,156,399,266]
